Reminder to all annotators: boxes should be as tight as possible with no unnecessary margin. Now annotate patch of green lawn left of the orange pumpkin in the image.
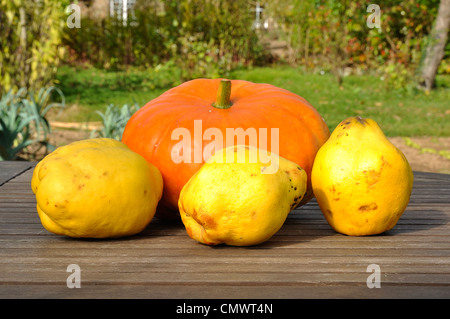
[54,66,176,121]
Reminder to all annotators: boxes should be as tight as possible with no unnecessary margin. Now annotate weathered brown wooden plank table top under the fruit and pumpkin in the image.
[0,162,450,299]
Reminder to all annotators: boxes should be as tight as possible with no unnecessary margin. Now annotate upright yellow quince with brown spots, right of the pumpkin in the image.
[311,117,413,236]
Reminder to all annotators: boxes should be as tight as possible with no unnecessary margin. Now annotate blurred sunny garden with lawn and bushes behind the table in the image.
[0,0,450,173]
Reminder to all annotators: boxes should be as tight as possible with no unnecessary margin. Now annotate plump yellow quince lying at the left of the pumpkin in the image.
[31,138,163,238]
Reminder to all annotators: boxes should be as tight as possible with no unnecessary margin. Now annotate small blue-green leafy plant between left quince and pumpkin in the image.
[91,103,139,141]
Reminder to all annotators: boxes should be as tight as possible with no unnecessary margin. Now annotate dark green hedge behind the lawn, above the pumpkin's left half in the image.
[64,0,263,81]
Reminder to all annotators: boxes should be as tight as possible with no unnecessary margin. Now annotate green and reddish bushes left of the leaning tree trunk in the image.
[265,0,439,88]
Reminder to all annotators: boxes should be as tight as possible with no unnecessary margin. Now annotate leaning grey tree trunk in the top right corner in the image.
[421,0,450,91]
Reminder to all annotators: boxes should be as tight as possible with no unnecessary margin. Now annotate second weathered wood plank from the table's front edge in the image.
[0,267,450,287]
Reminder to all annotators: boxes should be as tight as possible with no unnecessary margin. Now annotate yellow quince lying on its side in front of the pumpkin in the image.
[178,145,307,246]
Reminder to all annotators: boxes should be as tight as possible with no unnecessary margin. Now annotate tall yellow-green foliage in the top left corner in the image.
[0,0,68,94]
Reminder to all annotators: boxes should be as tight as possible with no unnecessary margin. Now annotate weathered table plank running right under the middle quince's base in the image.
[0,238,450,250]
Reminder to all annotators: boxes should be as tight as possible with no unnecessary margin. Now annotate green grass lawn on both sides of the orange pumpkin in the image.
[53,66,450,137]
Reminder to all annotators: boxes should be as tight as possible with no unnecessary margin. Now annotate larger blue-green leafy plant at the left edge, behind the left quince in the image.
[0,87,65,160]
